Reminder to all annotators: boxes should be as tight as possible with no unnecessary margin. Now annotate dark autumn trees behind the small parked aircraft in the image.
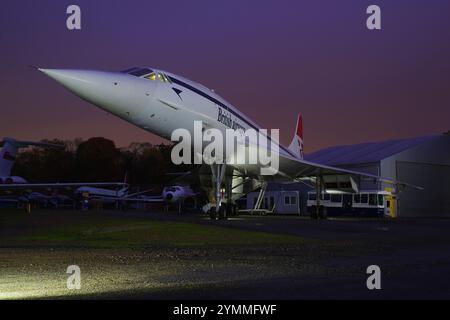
[12,137,191,186]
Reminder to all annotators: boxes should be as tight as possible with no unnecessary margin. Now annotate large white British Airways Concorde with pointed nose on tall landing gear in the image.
[39,67,414,219]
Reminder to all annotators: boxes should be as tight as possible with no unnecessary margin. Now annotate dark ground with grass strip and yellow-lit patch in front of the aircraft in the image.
[0,209,450,300]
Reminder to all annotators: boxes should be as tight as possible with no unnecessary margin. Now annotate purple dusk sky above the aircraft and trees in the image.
[0,0,450,152]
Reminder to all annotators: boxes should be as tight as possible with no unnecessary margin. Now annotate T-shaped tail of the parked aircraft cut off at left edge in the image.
[0,137,64,177]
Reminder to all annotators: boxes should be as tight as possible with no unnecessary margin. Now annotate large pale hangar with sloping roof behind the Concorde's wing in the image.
[306,133,450,217]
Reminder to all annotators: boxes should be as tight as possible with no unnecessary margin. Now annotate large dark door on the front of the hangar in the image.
[396,161,450,217]
